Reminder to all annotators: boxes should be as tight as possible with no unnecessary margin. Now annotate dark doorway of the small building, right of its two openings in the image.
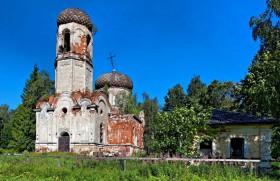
[230,138,244,158]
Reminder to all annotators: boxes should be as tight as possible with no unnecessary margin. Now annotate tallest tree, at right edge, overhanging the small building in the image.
[238,0,280,157]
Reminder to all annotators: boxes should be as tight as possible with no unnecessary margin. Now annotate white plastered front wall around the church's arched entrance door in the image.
[36,94,96,151]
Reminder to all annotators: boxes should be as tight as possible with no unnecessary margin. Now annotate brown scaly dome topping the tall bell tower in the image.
[57,8,93,31]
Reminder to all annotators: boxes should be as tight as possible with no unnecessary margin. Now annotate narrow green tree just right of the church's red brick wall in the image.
[141,93,159,155]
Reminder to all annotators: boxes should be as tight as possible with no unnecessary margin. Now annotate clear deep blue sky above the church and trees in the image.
[0,0,266,109]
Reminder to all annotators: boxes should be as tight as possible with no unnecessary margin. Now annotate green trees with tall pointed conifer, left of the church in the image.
[0,65,54,152]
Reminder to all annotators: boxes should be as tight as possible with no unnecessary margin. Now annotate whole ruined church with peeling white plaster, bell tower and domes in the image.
[35,8,145,156]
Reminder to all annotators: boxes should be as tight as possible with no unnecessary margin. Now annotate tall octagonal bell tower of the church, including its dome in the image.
[55,8,96,93]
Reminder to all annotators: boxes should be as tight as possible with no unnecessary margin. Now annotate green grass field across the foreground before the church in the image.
[0,156,280,181]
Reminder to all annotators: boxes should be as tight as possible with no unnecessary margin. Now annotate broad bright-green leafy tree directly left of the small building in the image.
[154,107,212,157]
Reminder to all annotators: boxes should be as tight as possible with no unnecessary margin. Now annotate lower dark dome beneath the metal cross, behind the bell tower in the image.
[95,71,133,90]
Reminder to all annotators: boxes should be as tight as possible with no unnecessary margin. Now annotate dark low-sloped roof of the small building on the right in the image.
[210,109,279,125]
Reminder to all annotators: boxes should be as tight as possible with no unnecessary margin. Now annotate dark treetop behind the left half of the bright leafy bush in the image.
[163,84,186,111]
